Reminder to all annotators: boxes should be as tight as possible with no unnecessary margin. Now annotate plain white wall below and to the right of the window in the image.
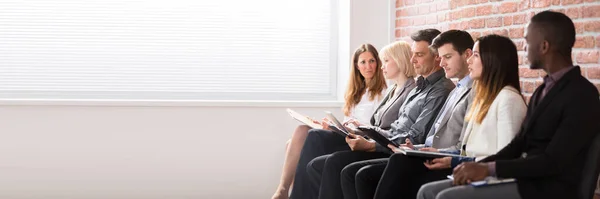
[0,0,393,199]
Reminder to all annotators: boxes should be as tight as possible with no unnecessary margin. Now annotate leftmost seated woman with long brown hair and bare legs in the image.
[272,44,393,199]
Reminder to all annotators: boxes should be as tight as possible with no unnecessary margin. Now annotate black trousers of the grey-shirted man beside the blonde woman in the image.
[307,151,390,199]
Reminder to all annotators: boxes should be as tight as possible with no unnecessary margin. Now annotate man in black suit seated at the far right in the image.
[418,11,600,199]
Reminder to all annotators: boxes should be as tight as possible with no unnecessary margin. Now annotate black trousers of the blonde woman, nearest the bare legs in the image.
[290,129,350,199]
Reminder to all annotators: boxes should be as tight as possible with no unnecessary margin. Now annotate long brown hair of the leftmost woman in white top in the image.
[344,44,387,116]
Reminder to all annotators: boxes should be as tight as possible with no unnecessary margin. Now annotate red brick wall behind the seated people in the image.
[395,0,600,101]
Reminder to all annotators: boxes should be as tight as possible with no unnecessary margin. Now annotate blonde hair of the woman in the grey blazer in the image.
[379,41,417,78]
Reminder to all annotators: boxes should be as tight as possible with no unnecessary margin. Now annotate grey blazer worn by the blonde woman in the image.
[371,78,417,129]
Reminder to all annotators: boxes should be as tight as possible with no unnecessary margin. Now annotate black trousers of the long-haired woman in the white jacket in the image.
[370,154,452,199]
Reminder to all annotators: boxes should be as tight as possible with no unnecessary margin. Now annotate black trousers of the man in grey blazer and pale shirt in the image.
[341,158,389,199]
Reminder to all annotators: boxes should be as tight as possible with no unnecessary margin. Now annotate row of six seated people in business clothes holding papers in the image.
[273,11,600,199]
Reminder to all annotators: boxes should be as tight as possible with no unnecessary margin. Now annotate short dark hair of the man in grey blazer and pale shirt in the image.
[431,30,475,55]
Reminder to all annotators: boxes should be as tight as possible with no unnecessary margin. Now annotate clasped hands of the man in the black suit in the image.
[453,162,489,185]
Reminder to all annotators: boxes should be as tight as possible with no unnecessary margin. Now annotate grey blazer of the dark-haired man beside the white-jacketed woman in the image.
[427,77,473,150]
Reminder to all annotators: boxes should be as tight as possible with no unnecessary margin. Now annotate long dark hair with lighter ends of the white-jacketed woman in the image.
[465,35,521,124]
